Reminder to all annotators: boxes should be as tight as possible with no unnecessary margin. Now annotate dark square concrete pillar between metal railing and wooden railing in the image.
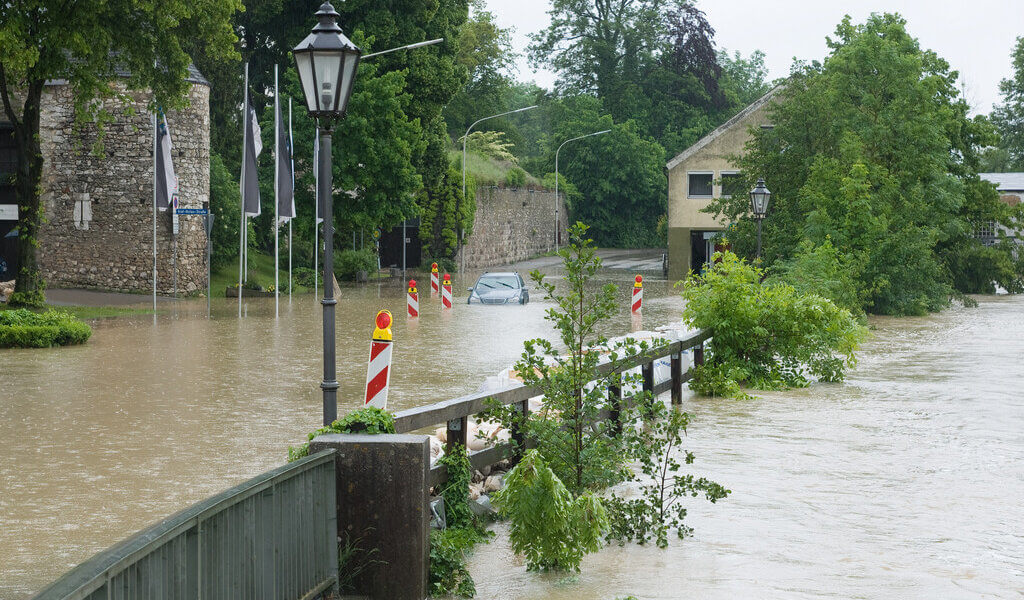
[309,434,430,600]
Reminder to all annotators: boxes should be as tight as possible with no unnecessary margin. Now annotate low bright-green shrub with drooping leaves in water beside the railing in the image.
[494,449,608,571]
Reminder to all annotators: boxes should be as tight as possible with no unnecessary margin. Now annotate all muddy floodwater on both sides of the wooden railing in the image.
[0,262,1024,600]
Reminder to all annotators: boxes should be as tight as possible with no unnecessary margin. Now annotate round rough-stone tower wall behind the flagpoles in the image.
[39,83,210,294]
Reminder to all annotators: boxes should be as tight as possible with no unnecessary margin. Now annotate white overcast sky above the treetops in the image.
[487,0,1024,114]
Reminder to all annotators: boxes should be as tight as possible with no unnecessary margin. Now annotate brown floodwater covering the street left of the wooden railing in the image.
[0,259,682,600]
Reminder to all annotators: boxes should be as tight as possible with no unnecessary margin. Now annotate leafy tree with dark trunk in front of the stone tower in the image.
[0,0,241,304]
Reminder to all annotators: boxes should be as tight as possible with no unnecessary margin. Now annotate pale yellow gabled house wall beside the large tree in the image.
[669,96,770,278]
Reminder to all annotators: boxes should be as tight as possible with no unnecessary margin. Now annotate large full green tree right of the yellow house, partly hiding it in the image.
[710,14,1022,314]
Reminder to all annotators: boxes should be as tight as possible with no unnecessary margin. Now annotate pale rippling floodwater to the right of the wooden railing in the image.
[470,296,1024,600]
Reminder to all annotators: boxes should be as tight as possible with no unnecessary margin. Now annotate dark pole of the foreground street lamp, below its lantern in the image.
[317,120,338,426]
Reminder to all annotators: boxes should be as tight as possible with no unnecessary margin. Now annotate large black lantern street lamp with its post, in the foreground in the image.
[292,2,443,425]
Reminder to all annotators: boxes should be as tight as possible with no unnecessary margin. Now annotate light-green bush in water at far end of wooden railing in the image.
[683,247,866,389]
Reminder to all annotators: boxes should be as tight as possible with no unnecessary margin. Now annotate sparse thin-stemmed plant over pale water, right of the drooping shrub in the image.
[606,404,729,548]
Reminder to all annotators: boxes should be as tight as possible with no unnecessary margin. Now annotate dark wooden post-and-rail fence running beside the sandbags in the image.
[394,331,711,485]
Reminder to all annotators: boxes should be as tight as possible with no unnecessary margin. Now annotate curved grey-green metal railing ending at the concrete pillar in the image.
[29,451,338,600]
